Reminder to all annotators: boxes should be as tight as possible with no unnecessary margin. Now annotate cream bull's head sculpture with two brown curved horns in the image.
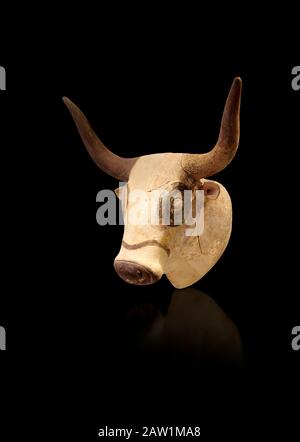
[64,78,242,288]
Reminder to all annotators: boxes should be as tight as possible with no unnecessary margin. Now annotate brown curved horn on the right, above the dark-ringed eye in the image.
[182,77,242,179]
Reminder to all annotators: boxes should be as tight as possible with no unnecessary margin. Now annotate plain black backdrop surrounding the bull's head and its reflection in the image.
[0,9,300,440]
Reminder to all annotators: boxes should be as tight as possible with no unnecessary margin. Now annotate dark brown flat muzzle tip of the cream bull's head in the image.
[114,260,160,285]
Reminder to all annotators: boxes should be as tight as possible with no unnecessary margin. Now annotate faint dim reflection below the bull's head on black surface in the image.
[126,288,242,367]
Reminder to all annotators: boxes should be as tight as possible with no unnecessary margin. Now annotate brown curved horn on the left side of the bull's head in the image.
[63,97,138,181]
